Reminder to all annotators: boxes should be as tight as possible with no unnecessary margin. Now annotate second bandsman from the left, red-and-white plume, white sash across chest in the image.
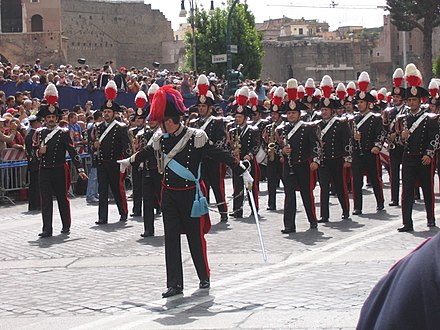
[92,80,132,225]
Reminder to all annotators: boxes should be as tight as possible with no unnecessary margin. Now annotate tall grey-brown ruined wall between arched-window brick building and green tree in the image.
[61,0,173,67]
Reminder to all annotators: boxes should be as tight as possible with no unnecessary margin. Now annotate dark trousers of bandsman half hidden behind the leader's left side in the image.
[142,168,162,234]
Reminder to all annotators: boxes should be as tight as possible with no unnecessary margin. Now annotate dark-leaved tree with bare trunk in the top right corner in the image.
[387,0,440,81]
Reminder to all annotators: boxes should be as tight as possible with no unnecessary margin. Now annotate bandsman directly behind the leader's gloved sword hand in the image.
[228,86,260,218]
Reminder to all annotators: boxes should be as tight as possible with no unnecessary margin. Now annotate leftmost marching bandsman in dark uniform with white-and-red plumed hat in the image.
[33,84,87,237]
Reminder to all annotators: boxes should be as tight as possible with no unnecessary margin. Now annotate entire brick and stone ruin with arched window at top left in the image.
[0,0,177,67]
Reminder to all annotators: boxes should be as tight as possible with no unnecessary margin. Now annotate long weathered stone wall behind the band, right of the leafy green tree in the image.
[261,41,374,83]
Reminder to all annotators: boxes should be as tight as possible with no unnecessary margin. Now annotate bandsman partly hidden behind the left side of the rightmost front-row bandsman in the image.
[383,68,408,206]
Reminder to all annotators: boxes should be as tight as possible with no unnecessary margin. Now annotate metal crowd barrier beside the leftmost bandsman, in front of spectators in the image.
[0,148,92,205]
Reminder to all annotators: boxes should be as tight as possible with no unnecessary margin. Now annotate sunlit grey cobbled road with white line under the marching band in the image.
[0,177,438,329]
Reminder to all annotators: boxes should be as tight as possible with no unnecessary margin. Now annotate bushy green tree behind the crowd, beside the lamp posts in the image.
[185,3,263,78]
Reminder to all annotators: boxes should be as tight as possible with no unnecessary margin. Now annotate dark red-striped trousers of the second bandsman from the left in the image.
[97,161,128,221]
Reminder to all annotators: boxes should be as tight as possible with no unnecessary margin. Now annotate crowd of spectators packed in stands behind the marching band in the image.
[0,59,273,163]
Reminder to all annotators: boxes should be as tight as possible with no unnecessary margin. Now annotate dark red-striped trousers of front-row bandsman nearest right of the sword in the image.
[283,162,316,229]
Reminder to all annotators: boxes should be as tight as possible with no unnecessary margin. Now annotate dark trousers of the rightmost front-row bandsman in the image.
[402,155,435,227]
